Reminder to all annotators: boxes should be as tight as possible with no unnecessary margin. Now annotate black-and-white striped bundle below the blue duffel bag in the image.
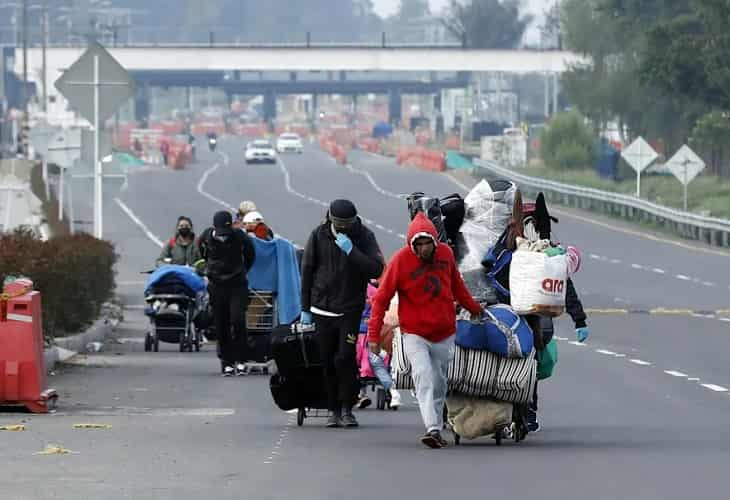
[448,345,537,404]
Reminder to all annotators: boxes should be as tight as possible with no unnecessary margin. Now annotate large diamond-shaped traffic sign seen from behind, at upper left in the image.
[55,42,134,123]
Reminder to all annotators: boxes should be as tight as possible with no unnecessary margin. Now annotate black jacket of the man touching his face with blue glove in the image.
[302,219,385,314]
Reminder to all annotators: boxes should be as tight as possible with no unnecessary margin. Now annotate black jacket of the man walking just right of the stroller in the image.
[199,228,256,284]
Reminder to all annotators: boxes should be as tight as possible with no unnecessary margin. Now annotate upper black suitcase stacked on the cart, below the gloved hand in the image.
[271,323,322,377]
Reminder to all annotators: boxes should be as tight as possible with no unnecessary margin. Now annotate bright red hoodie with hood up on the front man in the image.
[368,213,481,343]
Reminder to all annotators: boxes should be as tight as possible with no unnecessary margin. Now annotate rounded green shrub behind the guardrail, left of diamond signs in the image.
[540,111,593,170]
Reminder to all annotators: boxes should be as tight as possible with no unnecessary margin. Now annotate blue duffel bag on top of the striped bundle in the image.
[456,304,534,358]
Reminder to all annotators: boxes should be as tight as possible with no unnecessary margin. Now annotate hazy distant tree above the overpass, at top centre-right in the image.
[442,0,532,49]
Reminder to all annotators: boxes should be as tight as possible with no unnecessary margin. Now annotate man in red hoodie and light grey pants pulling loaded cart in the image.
[368,213,482,448]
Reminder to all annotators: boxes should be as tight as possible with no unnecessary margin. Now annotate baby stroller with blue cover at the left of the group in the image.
[144,265,208,352]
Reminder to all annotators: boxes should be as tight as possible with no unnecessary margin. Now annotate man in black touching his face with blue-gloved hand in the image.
[301,200,385,427]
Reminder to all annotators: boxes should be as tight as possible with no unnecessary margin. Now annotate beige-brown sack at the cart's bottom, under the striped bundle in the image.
[446,394,512,439]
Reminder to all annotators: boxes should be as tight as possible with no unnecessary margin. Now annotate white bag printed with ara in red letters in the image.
[509,248,568,317]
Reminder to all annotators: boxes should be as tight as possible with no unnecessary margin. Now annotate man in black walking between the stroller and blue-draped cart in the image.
[199,211,256,377]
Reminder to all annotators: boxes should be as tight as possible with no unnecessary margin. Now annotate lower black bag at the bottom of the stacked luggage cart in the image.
[269,366,327,411]
